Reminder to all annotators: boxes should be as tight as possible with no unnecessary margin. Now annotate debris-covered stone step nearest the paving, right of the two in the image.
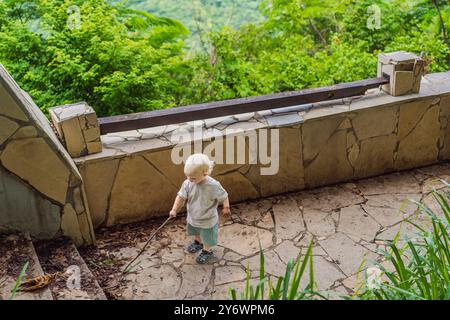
[34,238,107,300]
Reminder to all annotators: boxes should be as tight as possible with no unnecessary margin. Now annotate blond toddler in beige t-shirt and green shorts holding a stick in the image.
[170,153,230,264]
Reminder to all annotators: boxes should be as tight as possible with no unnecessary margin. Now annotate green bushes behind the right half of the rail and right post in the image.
[182,0,450,103]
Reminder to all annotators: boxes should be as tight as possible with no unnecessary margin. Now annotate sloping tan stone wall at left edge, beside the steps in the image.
[0,65,95,245]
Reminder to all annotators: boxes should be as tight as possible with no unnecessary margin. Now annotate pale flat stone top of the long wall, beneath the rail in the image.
[73,71,450,165]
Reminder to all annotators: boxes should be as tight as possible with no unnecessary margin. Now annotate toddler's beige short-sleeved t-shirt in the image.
[178,176,228,229]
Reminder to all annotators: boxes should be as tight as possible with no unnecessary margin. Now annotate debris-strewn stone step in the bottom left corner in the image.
[0,233,53,300]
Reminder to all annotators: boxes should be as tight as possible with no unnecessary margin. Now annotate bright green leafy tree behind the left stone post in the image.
[0,0,187,115]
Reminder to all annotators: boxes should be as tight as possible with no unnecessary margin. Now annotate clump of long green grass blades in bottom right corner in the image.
[357,185,450,300]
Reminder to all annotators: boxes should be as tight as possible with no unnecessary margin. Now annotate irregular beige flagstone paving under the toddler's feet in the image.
[98,163,450,299]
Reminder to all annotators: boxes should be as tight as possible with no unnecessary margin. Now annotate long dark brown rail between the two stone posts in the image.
[98,78,389,134]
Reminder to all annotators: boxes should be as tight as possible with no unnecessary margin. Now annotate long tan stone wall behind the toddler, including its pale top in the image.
[75,72,450,227]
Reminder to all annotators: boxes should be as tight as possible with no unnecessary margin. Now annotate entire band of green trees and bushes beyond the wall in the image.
[0,0,450,116]
